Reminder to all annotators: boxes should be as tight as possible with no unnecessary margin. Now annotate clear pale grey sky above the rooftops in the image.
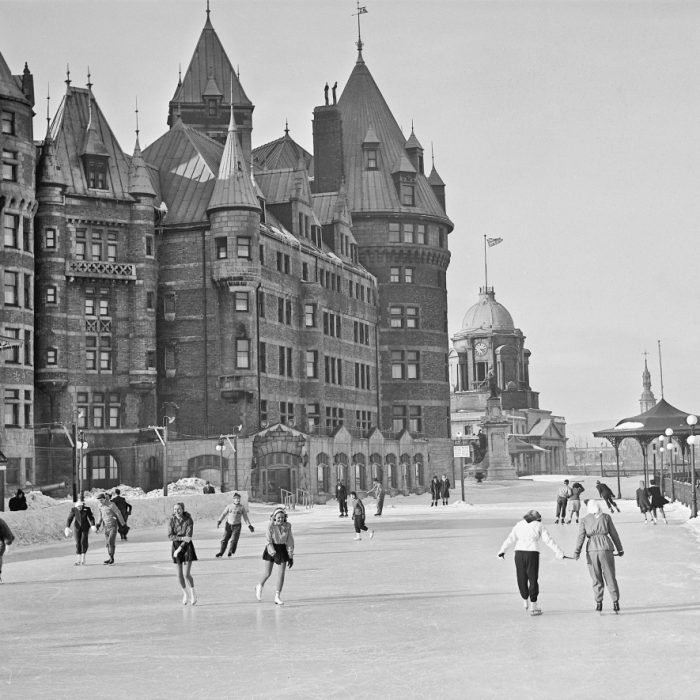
[0,0,700,438]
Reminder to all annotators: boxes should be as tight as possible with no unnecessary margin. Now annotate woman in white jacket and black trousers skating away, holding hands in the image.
[498,510,564,615]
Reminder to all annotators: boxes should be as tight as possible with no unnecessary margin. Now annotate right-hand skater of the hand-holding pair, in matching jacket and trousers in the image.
[574,499,624,612]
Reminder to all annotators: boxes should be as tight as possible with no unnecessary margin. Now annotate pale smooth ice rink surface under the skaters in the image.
[0,477,700,700]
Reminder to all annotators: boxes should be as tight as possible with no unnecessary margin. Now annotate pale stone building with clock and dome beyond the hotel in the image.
[450,287,567,474]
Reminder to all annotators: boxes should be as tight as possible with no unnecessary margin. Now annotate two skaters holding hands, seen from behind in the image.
[498,499,624,615]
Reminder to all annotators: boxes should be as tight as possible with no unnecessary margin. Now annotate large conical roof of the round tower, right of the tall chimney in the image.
[338,60,452,227]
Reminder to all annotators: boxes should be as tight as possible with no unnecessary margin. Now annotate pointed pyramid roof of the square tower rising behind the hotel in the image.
[172,15,251,105]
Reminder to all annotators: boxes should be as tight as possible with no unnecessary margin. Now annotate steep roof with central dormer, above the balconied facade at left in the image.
[51,86,129,198]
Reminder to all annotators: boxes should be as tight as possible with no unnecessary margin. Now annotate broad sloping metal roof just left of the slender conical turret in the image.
[143,119,224,224]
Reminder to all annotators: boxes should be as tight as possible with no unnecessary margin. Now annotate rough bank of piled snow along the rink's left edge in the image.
[0,487,248,546]
